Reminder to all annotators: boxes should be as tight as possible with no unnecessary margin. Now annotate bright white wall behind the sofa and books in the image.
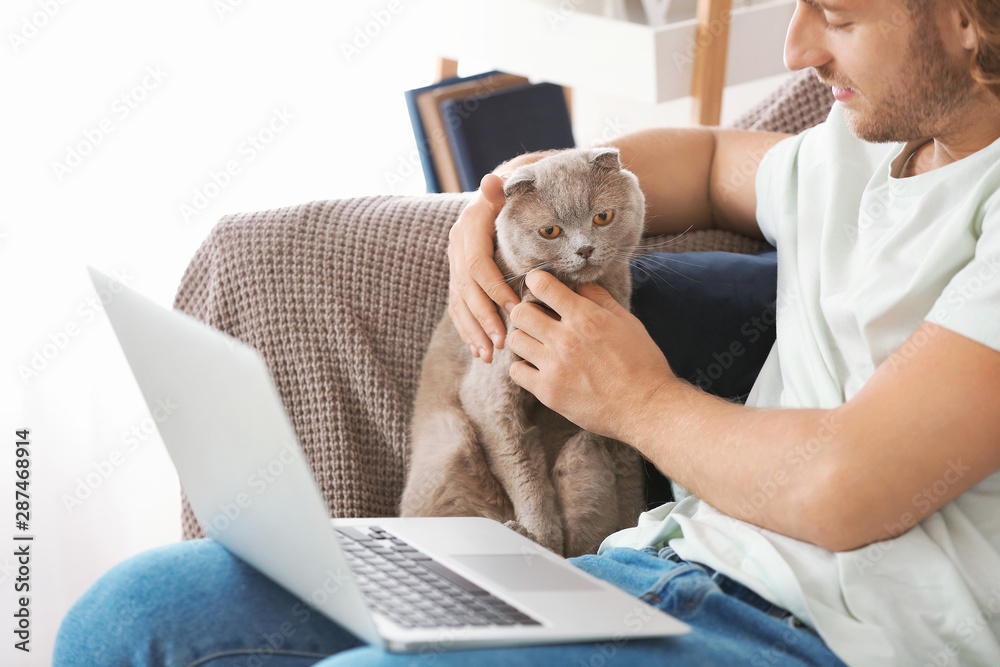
[0,0,792,665]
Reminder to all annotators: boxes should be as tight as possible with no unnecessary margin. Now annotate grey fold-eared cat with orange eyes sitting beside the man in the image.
[400,148,645,556]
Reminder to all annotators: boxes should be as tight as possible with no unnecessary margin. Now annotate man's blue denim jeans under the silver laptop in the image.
[53,540,843,667]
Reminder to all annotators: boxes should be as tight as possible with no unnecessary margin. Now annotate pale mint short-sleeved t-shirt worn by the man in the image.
[601,104,1000,667]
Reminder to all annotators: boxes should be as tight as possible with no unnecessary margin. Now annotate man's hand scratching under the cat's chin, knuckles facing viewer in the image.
[507,271,680,442]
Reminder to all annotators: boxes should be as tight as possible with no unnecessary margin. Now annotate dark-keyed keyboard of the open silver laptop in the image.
[337,526,541,628]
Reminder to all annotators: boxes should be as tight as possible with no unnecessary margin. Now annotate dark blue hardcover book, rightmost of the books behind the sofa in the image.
[441,83,575,191]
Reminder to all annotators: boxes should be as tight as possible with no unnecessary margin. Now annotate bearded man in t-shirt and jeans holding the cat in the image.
[55,0,1000,665]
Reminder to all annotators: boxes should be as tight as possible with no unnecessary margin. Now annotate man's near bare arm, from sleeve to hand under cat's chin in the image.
[509,271,1000,551]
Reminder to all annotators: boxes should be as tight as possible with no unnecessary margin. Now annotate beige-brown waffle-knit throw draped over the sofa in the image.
[174,69,829,538]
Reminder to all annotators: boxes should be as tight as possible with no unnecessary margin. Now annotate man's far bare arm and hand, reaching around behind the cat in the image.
[448,128,786,361]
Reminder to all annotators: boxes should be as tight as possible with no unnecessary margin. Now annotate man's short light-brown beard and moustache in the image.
[816,11,975,143]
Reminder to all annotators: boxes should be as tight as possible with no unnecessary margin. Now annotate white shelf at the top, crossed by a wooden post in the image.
[429,0,795,103]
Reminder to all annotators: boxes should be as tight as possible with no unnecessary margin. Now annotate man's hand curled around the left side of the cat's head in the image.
[448,174,520,363]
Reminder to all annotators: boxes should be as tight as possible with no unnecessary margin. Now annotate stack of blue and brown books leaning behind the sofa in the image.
[406,72,574,192]
